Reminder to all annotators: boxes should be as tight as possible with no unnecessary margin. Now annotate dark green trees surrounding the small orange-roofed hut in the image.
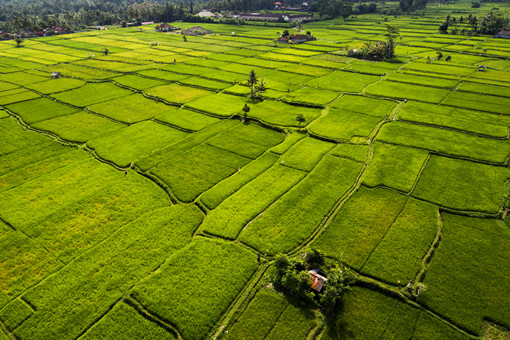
[270,249,350,315]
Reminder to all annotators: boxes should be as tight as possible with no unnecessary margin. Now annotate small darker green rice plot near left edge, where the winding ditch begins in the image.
[7,98,78,124]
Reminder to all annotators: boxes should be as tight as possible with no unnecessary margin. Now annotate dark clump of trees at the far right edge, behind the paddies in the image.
[439,12,510,35]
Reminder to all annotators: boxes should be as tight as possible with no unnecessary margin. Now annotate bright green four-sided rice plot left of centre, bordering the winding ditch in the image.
[87,121,188,167]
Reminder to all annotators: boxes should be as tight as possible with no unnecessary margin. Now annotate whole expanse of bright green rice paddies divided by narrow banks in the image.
[0,0,510,340]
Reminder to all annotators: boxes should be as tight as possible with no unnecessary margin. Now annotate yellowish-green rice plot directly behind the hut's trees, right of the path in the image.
[313,186,407,270]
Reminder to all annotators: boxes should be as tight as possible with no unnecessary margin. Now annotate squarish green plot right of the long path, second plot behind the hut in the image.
[363,143,429,192]
